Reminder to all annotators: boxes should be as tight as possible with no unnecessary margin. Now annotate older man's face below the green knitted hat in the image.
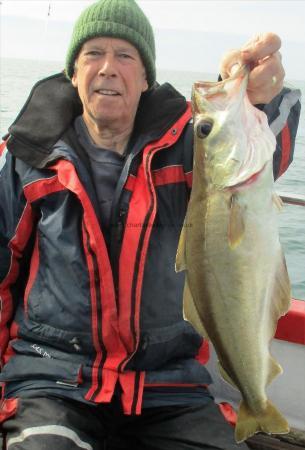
[72,37,148,128]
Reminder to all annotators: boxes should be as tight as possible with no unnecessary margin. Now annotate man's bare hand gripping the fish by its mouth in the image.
[220,33,285,105]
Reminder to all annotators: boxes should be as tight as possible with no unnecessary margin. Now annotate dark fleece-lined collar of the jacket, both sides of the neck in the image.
[7,73,187,168]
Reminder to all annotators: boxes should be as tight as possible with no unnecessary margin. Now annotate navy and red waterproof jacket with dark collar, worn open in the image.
[0,74,300,413]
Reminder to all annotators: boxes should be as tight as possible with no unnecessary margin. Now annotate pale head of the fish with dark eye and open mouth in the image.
[192,66,275,189]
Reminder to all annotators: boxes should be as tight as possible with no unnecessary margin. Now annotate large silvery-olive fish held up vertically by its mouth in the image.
[175,66,291,442]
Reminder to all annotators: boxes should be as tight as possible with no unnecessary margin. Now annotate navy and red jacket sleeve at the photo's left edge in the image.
[0,147,33,365]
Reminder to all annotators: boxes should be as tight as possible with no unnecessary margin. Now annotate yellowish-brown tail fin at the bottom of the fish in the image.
[235,401,289,442]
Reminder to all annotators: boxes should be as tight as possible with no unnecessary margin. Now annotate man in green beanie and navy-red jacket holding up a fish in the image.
[0,0,299,450]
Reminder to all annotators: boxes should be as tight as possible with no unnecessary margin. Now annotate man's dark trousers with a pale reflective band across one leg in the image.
[3,397,248,450]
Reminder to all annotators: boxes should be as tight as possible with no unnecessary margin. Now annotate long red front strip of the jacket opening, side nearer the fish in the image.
[119,105,191,356]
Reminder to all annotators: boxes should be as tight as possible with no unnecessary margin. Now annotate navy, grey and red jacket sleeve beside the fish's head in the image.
[257,88,301,179]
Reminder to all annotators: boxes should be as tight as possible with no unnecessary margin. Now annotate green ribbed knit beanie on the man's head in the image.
[66,0,156,87]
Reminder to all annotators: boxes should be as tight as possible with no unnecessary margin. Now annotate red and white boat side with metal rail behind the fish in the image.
[206,194,305,450]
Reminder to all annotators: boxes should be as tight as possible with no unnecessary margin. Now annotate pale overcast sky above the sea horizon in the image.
[0,0,305,80]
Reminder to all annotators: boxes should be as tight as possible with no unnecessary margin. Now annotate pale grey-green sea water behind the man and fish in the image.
[0,58,305,300]
